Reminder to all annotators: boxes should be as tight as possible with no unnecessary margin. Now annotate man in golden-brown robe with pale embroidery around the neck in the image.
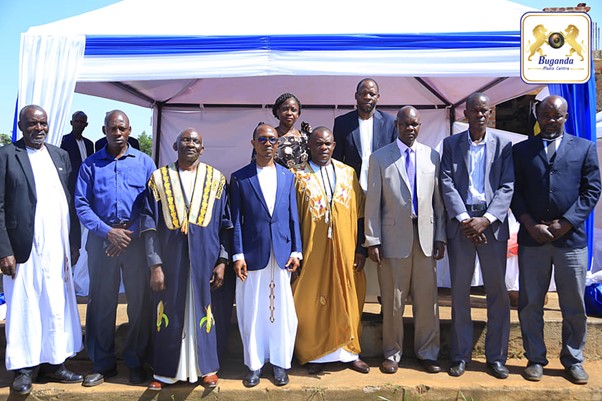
[293,127,370,374]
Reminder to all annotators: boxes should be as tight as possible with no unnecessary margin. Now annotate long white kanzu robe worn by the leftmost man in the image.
[3,147,82,370]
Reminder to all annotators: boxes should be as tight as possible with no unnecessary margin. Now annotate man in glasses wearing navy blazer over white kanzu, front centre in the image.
[230,124,301,387]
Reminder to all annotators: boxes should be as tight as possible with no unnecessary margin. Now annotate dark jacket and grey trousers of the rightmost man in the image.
[512,133,600,368]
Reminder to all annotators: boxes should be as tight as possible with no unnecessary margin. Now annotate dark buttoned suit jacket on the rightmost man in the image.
[512,133,600,249]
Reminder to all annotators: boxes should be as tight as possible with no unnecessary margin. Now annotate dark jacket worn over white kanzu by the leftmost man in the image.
[0,139,80,263]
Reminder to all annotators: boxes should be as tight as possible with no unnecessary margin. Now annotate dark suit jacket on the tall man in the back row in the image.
[332,110,397,178]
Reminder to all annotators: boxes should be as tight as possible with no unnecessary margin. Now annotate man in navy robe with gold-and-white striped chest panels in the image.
[141,128,232,390]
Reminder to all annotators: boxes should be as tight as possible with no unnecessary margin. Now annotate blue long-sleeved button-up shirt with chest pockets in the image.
[75,146,156,238]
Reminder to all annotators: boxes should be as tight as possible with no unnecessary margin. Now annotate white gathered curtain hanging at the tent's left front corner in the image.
[17,34,86,146]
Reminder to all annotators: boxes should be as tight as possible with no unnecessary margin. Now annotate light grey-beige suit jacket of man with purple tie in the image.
[364,142,445,259]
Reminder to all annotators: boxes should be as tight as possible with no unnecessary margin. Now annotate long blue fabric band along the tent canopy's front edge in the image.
[85,32,520,56]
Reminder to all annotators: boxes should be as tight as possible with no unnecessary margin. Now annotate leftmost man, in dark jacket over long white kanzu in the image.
[0,105,83,395]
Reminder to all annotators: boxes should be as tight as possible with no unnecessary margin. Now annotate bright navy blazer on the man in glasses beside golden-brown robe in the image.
[230,161,301,270]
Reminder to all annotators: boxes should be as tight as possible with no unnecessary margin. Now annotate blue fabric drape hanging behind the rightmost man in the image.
[548,61,596,270]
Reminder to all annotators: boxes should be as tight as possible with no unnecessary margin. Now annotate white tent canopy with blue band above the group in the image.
[19,0,536,174]
